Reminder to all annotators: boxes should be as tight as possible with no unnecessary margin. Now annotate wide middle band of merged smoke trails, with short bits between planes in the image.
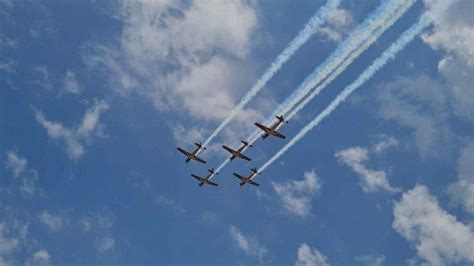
[209,0,415,180]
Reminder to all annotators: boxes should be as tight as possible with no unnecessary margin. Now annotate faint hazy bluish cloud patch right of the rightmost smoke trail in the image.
[377,75,452,157]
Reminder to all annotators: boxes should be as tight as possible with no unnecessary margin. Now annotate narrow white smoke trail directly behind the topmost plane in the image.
[286,0,415,120]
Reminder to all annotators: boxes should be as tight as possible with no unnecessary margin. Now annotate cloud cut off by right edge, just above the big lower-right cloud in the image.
[448,140,474,214]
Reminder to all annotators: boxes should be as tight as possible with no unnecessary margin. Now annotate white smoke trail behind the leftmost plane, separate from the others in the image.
[203,0,340,150]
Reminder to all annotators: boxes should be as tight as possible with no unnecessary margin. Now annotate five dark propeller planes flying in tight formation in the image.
[177,115,288,187]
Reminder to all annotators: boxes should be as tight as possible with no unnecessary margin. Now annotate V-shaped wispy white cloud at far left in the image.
[35,101,109,160]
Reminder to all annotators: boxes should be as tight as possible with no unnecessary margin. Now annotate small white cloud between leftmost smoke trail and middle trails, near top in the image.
[318,9,354,42]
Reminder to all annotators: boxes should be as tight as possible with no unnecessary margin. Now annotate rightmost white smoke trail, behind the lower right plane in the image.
[259,15,432,172]
